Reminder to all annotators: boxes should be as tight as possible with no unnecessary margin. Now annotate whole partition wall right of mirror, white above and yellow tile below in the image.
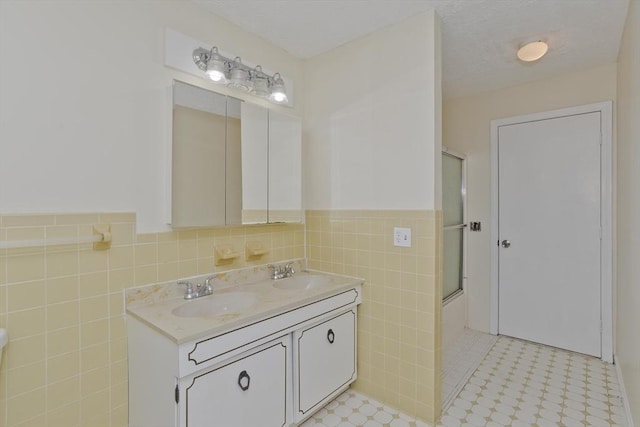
[303,12,442,424]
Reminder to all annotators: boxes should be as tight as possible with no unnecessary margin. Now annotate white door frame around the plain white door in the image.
[490,101,613,363]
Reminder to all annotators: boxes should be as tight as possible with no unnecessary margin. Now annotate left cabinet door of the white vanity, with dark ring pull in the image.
[181,336,290,427]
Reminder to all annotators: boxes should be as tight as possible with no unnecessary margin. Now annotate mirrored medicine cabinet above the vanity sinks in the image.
[171,81,302,228]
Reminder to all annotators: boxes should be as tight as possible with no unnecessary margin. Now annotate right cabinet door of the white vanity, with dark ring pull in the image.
[294,309,356,420]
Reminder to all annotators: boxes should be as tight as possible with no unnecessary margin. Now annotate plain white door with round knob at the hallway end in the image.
[495,111,602,357]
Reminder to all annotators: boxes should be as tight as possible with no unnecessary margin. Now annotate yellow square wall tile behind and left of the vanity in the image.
[0,214,304,427]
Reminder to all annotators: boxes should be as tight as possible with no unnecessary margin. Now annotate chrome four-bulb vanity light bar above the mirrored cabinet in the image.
[193,46,289,104]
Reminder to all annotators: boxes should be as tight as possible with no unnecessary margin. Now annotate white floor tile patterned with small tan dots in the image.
[302,336,627,427]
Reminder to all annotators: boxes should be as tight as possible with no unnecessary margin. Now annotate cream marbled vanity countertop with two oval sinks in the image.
[125,266,362,344]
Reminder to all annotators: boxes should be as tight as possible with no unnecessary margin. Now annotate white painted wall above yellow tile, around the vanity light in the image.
[0,0,303,231]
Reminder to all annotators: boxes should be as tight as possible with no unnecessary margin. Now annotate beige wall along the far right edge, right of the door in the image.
[615,0,640,425]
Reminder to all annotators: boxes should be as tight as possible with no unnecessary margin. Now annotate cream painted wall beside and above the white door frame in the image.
[443,64,616,332]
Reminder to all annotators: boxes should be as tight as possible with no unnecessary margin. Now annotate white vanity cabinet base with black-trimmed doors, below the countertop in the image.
[127,284,362,427]
